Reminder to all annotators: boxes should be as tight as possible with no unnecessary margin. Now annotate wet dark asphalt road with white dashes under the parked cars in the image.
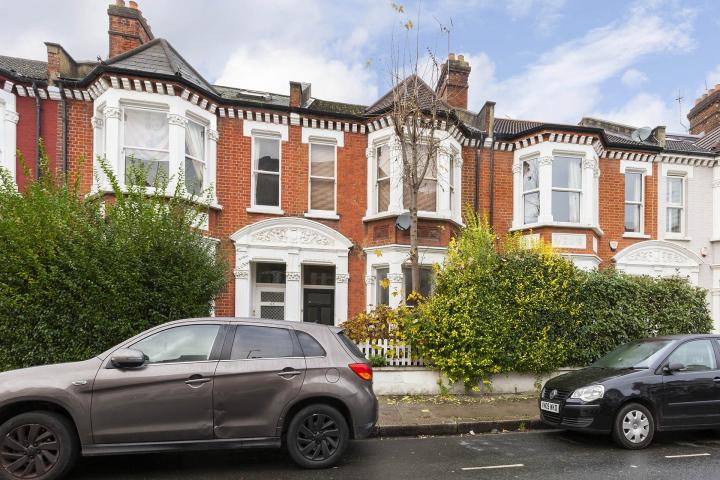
[69,430,720,480]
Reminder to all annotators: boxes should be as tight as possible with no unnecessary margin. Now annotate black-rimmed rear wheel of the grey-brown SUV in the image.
[285,404,350,468]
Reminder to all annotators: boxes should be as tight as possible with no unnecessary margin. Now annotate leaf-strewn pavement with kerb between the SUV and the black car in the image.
[375,395,541,437]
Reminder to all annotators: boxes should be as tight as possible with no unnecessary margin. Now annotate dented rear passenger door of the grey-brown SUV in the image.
[213,323,305,439]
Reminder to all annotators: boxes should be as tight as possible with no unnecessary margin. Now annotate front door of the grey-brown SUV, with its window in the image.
[91,324,222,444]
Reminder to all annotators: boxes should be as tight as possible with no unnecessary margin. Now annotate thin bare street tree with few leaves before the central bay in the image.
[372,4,459,301]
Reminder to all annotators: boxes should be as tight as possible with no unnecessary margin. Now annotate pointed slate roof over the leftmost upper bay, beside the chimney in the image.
[104,38,217,94]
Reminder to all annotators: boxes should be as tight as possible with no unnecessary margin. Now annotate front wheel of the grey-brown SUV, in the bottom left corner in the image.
[0,412,78,480]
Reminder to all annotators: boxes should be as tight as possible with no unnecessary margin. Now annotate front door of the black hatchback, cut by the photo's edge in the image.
[661,339,720,427]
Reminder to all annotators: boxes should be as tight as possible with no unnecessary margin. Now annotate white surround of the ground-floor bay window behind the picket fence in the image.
[365,244,447,312]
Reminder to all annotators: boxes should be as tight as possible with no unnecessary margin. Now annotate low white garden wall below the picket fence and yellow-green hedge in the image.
[373,366,572,395]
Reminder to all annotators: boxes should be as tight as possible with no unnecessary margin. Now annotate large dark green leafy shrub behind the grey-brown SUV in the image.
[0,152,227,370]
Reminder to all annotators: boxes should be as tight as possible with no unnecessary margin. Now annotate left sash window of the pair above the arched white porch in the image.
[252,136,280,207]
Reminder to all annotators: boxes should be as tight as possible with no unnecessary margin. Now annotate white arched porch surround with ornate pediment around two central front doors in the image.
[230,217,352,325]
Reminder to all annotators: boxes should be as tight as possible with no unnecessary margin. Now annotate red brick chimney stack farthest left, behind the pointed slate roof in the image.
[108,0,155,58]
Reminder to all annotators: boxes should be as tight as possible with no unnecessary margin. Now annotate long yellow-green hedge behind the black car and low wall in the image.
[402,214,712,386]
